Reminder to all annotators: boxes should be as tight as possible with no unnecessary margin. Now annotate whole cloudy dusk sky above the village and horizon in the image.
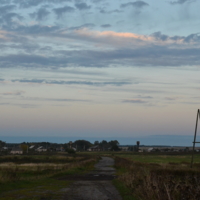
[0,0,200,145]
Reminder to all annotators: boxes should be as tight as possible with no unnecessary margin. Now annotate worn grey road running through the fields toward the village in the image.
[63,157,122,200]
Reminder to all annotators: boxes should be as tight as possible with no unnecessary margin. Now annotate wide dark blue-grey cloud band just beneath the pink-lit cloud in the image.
[0,41,200,69]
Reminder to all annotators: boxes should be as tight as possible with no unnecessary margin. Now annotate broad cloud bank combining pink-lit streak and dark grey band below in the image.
[0,24,200,69]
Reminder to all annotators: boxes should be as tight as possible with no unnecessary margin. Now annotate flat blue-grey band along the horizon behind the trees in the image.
[0,135,197,146]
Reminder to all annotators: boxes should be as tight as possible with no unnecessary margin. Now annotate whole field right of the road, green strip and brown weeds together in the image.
[115,153,200,200]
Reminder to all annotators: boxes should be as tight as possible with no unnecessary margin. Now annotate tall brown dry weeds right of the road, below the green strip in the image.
[116,157,200,200]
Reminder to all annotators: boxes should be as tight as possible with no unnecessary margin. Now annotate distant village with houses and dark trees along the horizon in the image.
[0,140,200,155]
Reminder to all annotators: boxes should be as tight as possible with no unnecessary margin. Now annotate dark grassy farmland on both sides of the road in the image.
[0,152,200,200]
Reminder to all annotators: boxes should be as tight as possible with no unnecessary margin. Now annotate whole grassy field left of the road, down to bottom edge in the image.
[0,154,98,200]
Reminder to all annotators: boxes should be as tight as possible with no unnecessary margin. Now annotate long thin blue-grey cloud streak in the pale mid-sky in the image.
[12,79,131,86]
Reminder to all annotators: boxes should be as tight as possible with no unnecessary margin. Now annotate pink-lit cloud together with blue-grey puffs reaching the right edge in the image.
[63,28,200,48]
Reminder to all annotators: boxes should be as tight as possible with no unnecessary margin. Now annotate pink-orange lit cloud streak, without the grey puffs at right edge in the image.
[62,28,188,48]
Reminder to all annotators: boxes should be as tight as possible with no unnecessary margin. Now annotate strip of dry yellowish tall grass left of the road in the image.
[0,157,96,184]
